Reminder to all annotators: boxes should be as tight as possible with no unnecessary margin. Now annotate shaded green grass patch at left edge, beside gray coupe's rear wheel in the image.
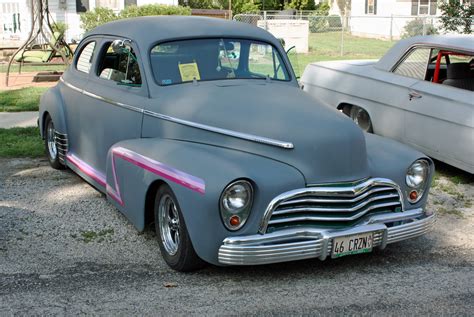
[0,127,45,158]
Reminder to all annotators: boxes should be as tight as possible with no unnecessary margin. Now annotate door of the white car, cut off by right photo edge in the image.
[405,80,474,173]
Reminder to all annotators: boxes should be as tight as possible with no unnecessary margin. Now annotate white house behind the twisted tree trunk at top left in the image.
[0,0,178,46]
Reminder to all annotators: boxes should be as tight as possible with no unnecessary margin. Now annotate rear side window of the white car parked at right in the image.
[394,48,431,80]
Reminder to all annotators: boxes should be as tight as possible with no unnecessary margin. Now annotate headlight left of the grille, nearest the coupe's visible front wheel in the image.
[219,180,253,231]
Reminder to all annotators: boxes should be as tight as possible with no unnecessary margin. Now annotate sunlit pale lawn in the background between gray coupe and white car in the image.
[290,32,395,76]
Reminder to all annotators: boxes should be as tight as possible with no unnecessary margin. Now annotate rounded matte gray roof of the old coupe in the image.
[86,16,277,46]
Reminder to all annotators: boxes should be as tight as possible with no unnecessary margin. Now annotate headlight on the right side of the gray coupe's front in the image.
[405,159,430,204]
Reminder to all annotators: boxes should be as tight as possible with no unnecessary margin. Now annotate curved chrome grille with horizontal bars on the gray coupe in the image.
[260,178,403,233]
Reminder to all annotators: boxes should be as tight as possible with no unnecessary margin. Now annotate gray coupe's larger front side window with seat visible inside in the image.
[97,42,142,86]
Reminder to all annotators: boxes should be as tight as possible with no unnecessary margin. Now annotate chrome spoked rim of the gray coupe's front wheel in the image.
[158,194,180,255]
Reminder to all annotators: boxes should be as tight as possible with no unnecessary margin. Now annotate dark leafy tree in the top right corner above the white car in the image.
[439,0,474,34]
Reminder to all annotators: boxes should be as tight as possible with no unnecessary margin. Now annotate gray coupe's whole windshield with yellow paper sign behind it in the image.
[151,39,290,86]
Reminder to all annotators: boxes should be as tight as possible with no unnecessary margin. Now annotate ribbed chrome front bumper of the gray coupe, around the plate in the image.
[218,209,436,265]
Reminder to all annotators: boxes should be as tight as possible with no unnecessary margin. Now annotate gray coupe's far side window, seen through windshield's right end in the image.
[249,43,289,80]
